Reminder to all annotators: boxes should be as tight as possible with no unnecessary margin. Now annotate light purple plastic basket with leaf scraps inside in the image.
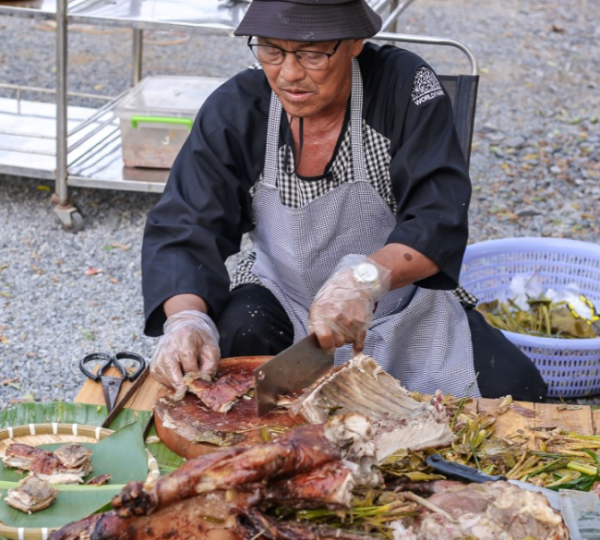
[460,237,600,398]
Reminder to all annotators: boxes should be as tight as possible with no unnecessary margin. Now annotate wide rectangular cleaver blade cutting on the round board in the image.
[254,334,333,416]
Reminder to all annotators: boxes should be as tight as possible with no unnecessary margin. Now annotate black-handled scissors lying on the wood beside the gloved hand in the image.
[79,351,146,413]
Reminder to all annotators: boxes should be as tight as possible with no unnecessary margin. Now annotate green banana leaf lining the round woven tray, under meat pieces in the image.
[0,422,148,528]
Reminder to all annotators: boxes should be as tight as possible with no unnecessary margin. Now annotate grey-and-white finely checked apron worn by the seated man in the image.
[250,60,480,397]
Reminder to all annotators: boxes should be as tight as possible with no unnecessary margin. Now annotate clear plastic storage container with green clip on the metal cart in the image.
[115,76,225,169]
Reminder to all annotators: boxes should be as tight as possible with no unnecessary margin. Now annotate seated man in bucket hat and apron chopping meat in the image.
[143,0,546,401]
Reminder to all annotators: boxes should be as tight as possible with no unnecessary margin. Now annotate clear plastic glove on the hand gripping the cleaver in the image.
[308,255,391,352]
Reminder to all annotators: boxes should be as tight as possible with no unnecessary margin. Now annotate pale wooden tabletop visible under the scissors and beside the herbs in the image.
[75,373,600,437]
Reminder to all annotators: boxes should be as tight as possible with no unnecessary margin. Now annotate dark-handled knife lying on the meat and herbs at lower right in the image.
[425,454,600,540]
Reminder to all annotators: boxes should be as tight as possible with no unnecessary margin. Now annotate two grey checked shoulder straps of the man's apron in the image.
[263,58,367,187]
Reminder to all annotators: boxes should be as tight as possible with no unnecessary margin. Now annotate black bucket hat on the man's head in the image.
[234,0,381,41]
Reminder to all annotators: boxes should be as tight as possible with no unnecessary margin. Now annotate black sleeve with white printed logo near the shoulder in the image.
[360,47,471,289]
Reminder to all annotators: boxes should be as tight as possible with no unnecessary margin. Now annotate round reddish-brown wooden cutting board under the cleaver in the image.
[154,356,303,459]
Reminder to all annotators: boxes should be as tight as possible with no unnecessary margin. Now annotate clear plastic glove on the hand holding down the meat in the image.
[150,310,221,401]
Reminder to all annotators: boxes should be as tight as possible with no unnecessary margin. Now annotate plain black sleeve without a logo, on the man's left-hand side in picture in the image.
[142,70,270,336]
